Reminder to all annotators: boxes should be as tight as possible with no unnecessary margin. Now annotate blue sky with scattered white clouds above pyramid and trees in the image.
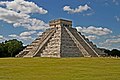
[0,0,120,49]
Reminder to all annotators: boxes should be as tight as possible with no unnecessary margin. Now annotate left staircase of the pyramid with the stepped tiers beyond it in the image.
[16,29,55,57]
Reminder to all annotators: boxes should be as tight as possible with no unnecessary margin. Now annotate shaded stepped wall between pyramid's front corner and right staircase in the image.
[61,27,83,57]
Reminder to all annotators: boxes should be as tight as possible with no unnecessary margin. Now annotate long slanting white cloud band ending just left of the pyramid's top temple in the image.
[0,7,49,30]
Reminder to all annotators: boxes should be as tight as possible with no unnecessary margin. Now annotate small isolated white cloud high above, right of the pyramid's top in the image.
[63,4,91,13]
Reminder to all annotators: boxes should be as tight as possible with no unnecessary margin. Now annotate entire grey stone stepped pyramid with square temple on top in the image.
[16,19,104,58]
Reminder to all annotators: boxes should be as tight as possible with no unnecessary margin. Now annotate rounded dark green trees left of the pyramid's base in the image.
[0,39,23,57]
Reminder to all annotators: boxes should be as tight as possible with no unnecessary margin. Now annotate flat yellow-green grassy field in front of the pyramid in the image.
[0,58,120,80]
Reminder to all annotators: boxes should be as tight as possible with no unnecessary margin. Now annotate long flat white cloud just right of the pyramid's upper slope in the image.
[76,26,112,36]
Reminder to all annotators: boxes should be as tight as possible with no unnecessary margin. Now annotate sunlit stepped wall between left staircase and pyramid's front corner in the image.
[41,28,61,57]
